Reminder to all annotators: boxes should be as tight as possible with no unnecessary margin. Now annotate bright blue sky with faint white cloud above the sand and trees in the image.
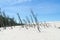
[0,0,60,21]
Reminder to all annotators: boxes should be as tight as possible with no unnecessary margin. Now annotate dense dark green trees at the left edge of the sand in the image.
[0,8,18,27]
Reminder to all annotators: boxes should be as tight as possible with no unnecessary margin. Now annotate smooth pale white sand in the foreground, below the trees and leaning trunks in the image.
[0,21,60,40]
